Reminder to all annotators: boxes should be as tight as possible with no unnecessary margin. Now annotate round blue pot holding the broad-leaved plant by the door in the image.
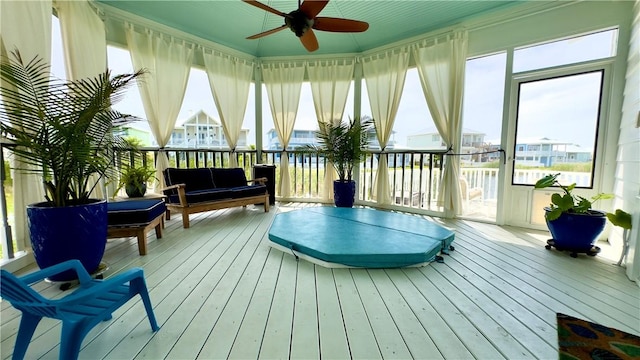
[545,208,607,252]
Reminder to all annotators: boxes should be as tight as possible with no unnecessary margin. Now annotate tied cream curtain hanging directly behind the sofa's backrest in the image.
[202,51,253,168]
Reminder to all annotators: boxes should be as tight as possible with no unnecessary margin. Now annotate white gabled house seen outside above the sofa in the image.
[166,110,249,149]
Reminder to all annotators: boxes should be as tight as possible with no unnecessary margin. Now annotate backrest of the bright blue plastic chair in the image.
[0,270,57,317]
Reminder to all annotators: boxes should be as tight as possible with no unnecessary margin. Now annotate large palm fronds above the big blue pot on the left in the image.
[0,50,144,207]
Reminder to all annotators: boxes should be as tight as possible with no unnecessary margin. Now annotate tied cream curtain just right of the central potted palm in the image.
[362,48,409,205]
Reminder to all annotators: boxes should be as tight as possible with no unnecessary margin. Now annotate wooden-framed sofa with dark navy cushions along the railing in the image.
[163,168,269,228]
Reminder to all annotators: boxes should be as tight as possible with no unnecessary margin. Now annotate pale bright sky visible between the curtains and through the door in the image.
[52,17,615,148]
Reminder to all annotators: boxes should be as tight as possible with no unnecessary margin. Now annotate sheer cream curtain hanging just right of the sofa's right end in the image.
[262,62,305,198]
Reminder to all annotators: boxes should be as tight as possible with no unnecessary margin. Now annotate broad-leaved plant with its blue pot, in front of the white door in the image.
[535,173,613,257]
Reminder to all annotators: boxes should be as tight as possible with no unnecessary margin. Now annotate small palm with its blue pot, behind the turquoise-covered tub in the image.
[309,117,373,207]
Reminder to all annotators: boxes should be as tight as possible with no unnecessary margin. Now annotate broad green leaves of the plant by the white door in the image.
[535,173,613,221]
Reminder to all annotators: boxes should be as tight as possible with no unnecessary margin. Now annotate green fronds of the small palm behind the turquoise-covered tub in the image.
[305,116,373,182]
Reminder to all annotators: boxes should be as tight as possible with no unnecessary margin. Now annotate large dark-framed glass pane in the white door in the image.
[513,70,604,187]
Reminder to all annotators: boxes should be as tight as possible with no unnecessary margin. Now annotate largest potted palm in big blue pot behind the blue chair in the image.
[0,50,143,280]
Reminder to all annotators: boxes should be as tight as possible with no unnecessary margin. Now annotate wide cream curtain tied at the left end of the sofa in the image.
[125,24,194,192]
